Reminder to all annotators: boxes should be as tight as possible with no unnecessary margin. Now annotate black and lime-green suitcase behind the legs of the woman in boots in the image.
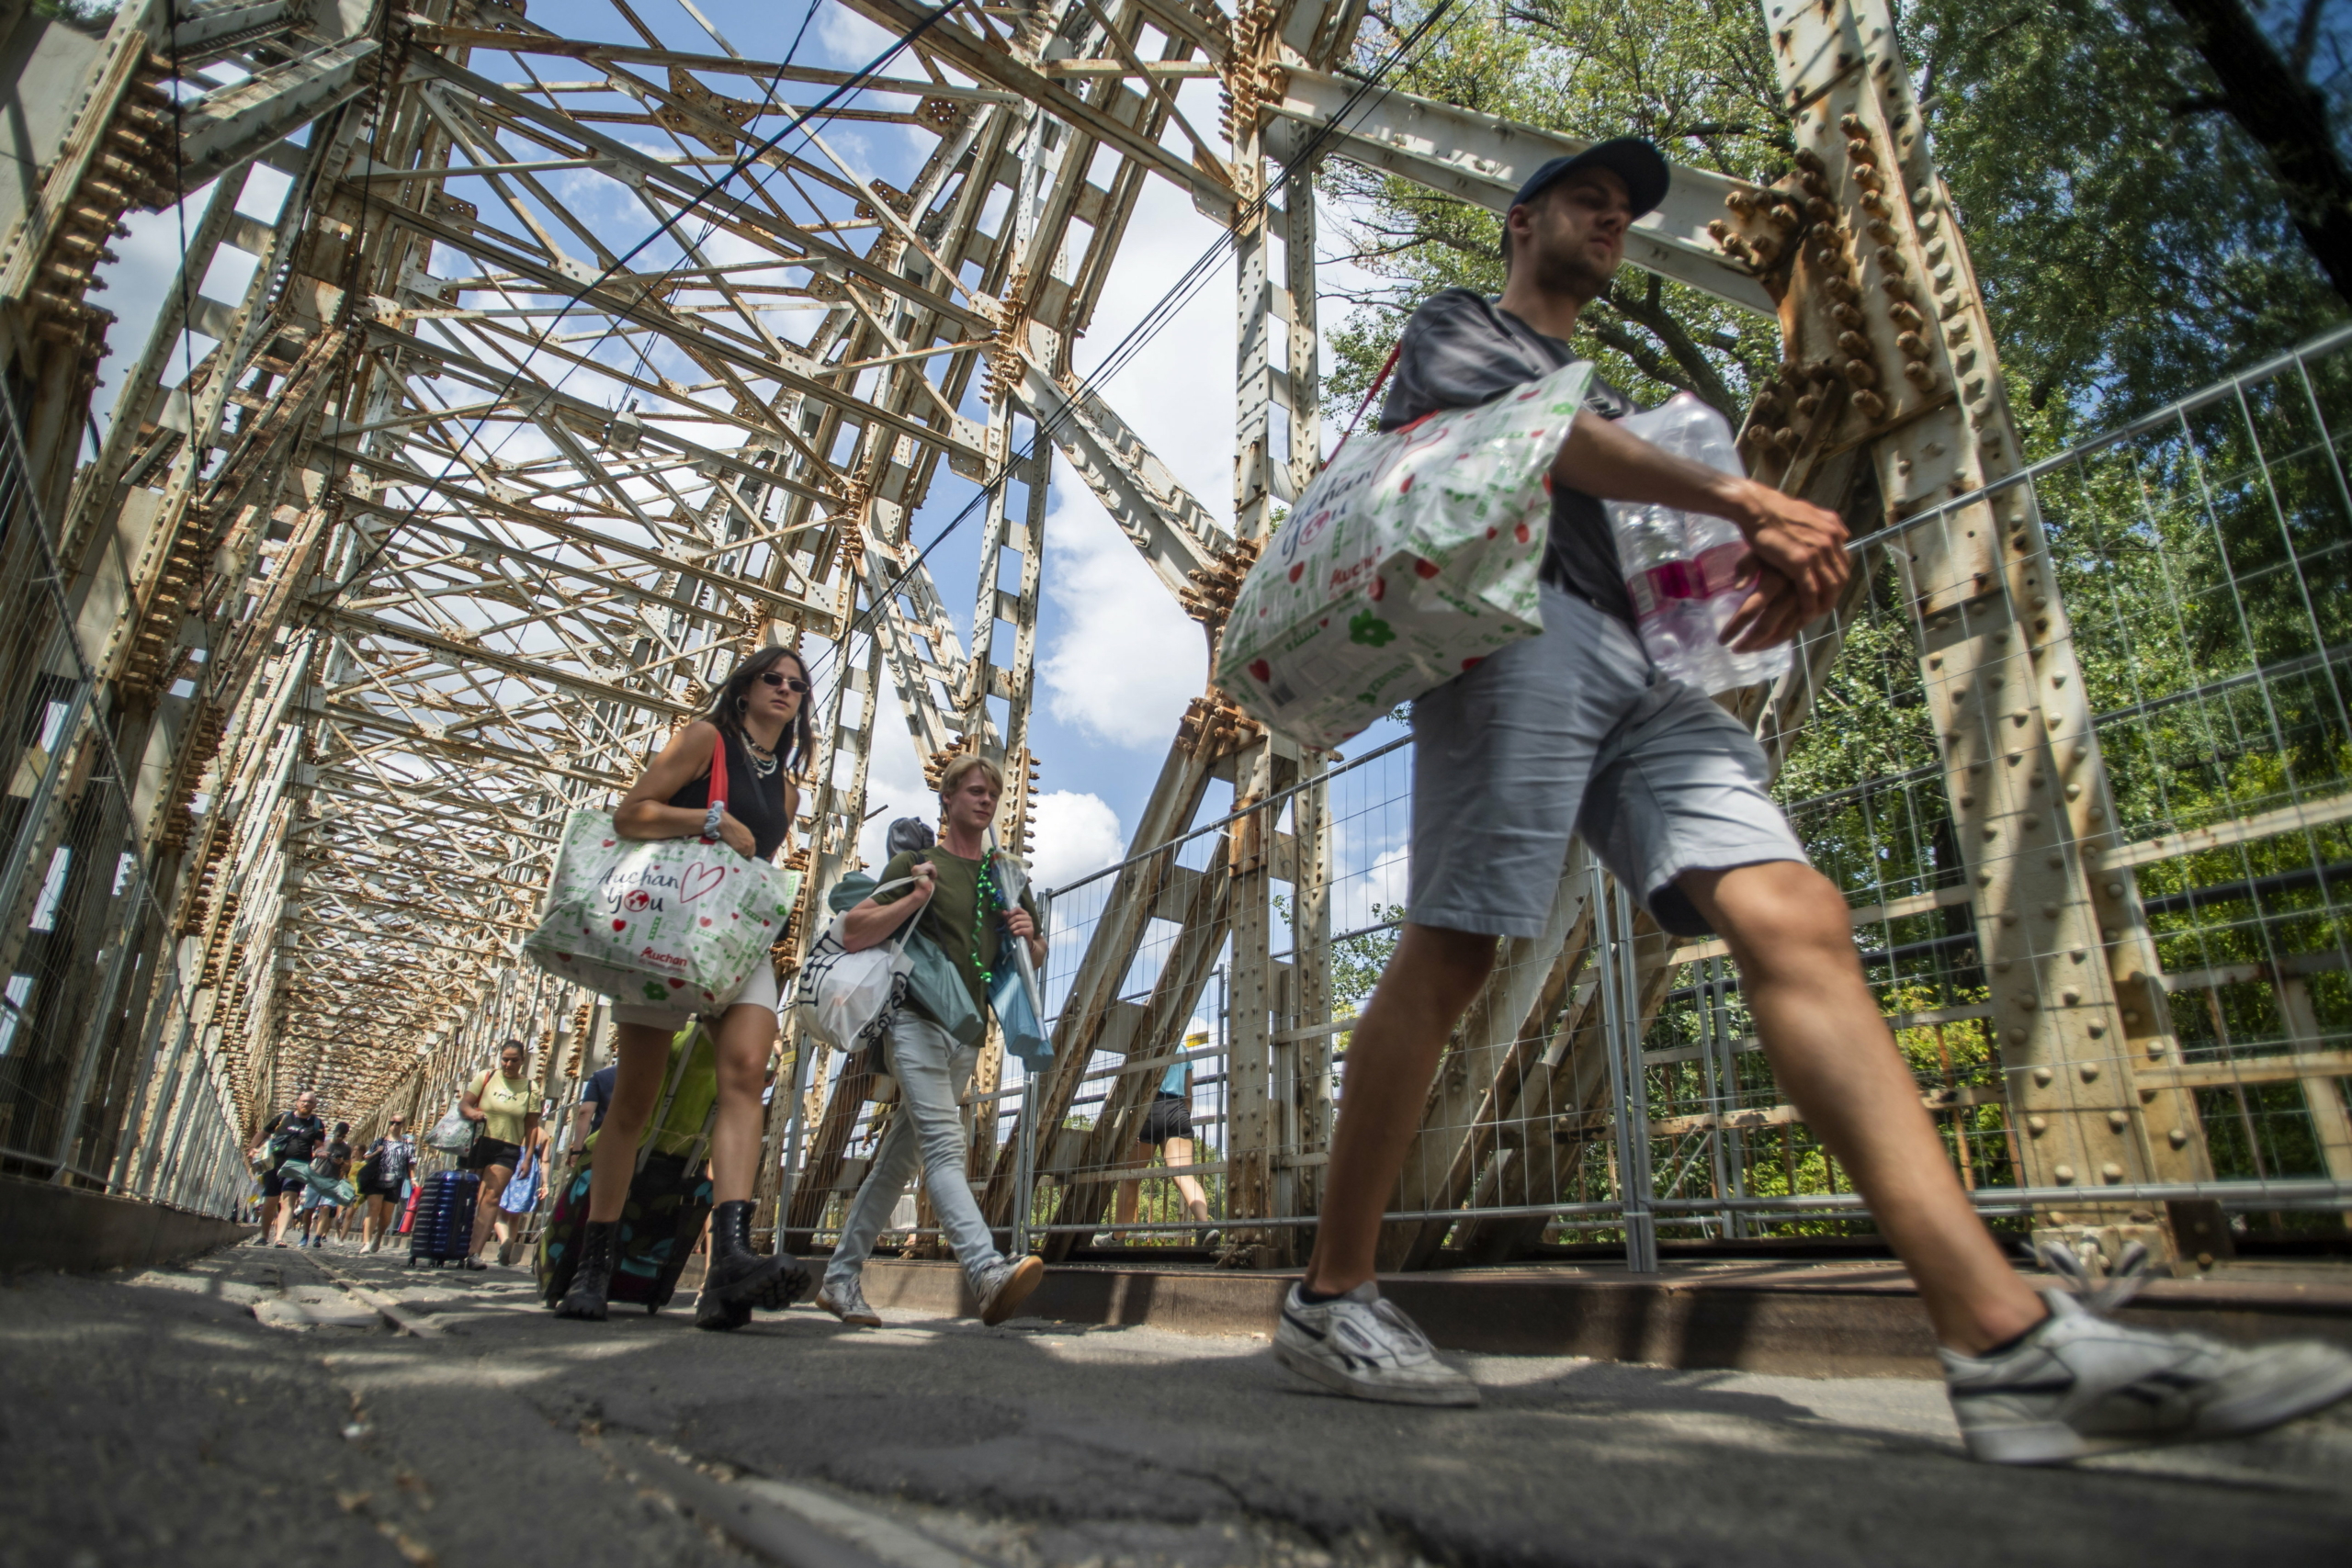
[538,1022,719,1314]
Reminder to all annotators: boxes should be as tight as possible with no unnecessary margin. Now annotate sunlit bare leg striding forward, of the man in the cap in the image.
[1675,861,2046,1354]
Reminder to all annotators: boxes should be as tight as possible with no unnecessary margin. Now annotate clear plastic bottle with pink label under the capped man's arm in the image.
[1606,392,1788,696]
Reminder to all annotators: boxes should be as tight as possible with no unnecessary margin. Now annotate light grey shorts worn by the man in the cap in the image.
[1407,585,1806,936]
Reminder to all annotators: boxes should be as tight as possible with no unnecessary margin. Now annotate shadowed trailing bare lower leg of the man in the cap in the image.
[1306,924,1494,1295]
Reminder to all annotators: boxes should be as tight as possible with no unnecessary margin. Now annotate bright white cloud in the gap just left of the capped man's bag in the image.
[1037,472,1209,748]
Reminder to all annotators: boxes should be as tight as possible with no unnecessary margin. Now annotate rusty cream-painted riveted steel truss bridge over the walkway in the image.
[0,0,2352,1262]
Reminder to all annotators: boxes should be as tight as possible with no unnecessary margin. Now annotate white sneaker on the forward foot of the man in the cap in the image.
[1940,1291,2352,1464]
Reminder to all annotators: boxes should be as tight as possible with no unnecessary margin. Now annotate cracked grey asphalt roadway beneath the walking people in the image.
[0,1246,2352,1568]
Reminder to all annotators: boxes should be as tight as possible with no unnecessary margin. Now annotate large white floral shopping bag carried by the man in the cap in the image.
[1216,362,1592,748]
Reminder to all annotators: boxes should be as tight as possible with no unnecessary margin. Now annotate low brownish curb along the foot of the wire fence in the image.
[865,1260,2352,1378]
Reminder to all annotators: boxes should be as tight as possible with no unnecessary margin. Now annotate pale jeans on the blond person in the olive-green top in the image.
[826,1009,1004,1286]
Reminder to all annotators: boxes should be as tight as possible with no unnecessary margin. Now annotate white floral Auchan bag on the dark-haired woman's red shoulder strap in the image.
[522,743,799,1013]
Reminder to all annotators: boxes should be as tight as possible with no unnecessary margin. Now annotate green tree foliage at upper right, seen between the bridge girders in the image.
[1324,0,2352,449]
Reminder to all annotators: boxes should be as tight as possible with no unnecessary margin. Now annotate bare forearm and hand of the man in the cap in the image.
[1553,419,1853,651]
